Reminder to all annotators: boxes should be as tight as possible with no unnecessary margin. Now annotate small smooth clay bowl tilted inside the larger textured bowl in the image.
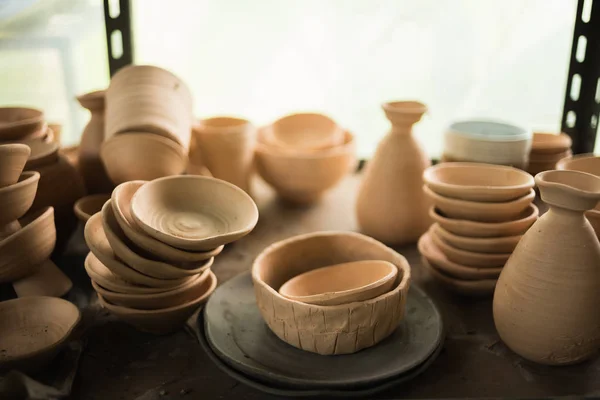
[279,260,398,306]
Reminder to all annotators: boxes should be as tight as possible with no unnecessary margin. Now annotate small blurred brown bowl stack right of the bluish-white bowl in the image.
[527,132,573,175]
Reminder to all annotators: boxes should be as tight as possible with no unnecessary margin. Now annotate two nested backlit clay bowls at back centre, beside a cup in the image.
[256,113,356,204]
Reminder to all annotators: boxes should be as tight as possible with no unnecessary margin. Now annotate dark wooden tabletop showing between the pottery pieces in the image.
[49,176,600,400]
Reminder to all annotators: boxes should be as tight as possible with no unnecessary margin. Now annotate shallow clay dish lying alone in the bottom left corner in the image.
[0,296,80,372]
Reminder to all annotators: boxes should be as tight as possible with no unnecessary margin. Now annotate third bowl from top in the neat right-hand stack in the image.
[429,203,539,238]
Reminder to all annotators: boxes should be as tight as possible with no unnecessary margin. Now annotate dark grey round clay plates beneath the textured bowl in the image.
[204,273,443,390]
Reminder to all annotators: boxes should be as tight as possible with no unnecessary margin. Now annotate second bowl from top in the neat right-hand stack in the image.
[423,186,535,222]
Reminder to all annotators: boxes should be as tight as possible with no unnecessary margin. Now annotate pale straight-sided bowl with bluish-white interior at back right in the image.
[442,120,532,168]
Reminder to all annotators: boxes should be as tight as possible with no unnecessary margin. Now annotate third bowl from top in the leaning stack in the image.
[102,200,214,279]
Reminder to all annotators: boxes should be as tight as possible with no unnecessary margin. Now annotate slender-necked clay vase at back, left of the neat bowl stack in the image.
[356,101,431,245]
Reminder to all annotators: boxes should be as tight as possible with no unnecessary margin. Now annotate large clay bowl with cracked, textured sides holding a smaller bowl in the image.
[252,232,410,354]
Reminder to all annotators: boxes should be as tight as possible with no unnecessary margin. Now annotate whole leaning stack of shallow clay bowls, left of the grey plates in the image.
[85,176,258,334]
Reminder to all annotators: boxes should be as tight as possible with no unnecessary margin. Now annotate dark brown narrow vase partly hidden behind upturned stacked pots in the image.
[77,90,114,194]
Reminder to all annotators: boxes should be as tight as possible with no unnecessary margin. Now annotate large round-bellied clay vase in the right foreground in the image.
[494,171,600,365]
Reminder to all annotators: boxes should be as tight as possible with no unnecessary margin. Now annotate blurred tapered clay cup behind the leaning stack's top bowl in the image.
[192,117,256,193]
